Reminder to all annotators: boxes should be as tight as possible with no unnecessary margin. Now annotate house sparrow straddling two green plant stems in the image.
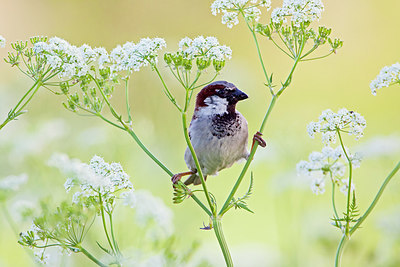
[171,81,266,185]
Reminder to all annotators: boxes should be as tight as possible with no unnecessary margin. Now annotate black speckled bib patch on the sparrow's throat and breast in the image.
[211,112,242,139]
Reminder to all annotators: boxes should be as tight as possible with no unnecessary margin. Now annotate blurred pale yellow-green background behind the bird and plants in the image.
[0,0,400,266]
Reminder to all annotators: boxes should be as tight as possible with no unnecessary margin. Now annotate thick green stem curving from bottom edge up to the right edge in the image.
[335,161,400,267]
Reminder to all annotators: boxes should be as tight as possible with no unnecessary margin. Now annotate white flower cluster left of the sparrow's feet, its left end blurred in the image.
[48,154,133,203]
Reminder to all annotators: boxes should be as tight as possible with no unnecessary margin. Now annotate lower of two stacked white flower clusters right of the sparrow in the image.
[296,146,361,195]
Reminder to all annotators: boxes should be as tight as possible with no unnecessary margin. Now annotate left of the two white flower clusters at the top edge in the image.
[211,0,271,28]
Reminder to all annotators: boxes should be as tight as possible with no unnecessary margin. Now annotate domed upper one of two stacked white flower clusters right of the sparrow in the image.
[307,108,367,144]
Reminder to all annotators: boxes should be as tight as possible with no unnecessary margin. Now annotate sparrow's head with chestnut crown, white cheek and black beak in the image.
[196,81,248,115]
